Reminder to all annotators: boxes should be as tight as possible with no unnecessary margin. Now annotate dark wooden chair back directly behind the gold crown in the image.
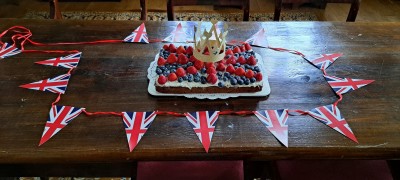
[167,0,250,21]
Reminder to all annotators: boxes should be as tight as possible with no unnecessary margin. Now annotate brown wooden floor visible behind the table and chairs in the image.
[0,0,400,22]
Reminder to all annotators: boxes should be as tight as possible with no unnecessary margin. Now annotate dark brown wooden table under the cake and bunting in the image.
[0,19,400,176]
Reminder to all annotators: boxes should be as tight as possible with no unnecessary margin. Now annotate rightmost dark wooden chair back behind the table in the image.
[274,0,361,22]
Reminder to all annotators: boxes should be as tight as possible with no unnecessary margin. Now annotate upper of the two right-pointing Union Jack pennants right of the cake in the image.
[304,53,343,70]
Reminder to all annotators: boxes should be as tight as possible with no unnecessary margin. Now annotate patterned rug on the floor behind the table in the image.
[23,11,318,21]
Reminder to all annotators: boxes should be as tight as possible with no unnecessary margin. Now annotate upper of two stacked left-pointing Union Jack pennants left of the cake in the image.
[35,52,82,69]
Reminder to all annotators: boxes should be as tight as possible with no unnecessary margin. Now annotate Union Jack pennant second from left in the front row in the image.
[122,111,157,152]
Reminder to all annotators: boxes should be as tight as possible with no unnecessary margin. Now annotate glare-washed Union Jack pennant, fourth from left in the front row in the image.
[254,109,289,147]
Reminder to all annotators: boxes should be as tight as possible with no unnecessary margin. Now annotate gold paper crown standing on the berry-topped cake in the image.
[193,21,228,62]
